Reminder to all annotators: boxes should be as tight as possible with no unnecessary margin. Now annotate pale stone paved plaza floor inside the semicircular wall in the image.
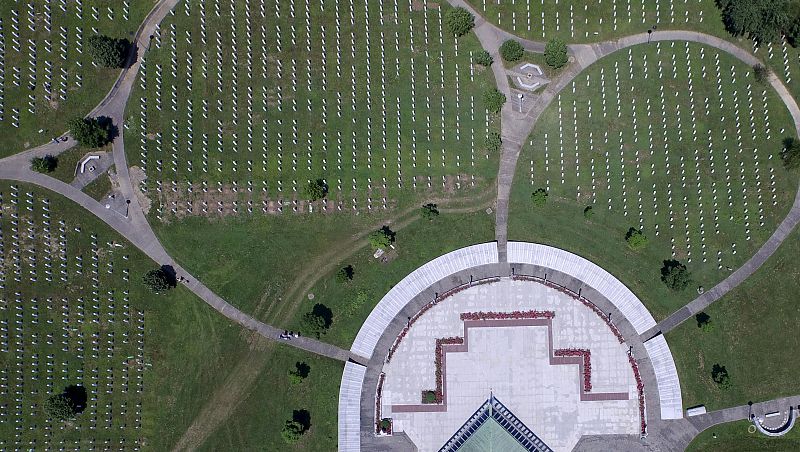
[381,279,639,451]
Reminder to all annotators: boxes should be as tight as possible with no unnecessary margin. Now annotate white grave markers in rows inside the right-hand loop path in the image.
[530,43,777,268]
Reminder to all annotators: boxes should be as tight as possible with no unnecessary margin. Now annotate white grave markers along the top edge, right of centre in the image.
[480,0,704,39]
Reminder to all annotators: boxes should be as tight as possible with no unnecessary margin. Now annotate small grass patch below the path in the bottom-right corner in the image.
[686,421,800,452]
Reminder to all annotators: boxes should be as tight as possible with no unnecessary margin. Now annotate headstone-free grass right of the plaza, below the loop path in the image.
[667,230,800,409]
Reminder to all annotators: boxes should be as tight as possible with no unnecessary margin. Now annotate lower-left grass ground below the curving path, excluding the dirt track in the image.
[0,182,341,450]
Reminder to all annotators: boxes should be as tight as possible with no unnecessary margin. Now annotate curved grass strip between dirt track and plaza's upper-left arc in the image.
[287,212,494,349]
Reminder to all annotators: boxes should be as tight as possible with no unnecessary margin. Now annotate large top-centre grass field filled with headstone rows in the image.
[127,0,497,217]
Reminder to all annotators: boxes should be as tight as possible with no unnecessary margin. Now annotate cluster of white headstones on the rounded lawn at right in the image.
[530,42,777,268]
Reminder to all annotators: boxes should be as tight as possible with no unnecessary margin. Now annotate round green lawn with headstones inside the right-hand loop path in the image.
[509,42,797,319]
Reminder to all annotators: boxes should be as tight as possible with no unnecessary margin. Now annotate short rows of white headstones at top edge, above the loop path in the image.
[482,0,704,38]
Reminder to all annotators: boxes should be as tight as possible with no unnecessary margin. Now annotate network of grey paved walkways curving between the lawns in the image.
[0,0,800,450]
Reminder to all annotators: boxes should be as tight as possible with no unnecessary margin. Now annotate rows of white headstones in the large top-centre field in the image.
[132,0,488,215]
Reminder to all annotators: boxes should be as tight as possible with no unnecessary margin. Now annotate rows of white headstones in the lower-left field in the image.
[0,185,144,449]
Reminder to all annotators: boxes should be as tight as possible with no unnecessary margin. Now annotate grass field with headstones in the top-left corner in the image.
[0,0,153,157]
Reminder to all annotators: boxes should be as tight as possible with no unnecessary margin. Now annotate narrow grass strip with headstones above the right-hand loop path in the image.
[460,0,725,43]
